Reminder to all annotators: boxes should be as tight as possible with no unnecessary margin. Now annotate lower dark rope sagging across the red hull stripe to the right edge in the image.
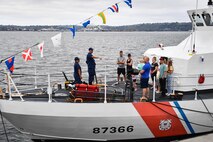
[150,102,213,129]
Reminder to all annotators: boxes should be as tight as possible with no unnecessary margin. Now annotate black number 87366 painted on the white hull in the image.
[93,126,134,134]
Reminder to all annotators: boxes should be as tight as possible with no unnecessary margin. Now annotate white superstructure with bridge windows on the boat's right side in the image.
[145,6,213,91]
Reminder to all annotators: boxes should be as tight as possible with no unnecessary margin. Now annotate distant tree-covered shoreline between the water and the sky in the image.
[0,22,192,32]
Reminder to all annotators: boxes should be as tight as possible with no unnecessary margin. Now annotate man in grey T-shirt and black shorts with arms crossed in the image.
[117,51,126,83]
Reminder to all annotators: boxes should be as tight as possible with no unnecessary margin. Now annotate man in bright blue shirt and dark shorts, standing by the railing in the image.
[140,56,151,100]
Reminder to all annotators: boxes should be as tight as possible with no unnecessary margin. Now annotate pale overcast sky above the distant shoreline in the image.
[0,0,208,25]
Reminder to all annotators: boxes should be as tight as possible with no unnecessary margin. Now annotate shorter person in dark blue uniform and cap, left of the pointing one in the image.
[74,57,82,84]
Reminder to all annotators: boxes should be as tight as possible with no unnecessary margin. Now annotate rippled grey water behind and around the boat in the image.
[0,32,189,142]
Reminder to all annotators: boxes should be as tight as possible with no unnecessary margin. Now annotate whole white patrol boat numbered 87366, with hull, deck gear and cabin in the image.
[0,1,213,141]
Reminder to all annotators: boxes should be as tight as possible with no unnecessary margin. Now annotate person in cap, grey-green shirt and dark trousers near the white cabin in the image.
[159,57,167,97]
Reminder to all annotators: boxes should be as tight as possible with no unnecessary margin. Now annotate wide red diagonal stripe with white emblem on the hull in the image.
[133,102,187,137]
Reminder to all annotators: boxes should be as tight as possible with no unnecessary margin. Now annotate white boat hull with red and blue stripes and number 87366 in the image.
[0,100,213,141]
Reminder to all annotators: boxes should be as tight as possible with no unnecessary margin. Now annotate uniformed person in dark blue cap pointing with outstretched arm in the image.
[86,48,101,85]
